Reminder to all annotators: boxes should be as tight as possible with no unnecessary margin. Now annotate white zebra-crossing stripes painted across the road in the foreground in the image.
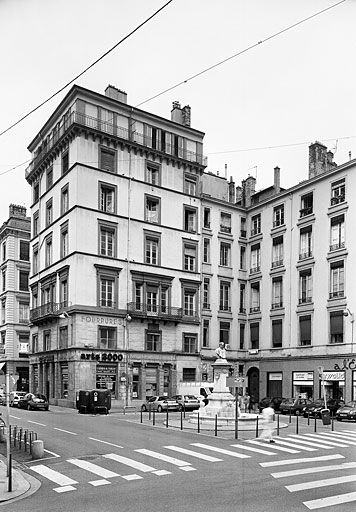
[30,430,356,510]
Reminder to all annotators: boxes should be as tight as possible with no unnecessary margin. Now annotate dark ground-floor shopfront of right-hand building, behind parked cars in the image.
[259,356,356,402]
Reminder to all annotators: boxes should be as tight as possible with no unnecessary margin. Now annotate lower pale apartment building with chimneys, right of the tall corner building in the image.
[201,143,356,400]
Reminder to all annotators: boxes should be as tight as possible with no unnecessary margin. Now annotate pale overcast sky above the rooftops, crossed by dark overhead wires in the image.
[0,0,356,223]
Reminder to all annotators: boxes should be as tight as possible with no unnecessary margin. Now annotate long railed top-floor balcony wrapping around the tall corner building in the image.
[25,110,208,178]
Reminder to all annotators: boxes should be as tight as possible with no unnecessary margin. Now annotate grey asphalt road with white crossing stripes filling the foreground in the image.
[5,407,356,512]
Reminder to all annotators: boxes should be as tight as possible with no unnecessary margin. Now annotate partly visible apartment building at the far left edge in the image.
[0,204,31,391]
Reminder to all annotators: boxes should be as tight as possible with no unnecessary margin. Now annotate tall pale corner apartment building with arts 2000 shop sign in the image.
[26,86,206,404]
